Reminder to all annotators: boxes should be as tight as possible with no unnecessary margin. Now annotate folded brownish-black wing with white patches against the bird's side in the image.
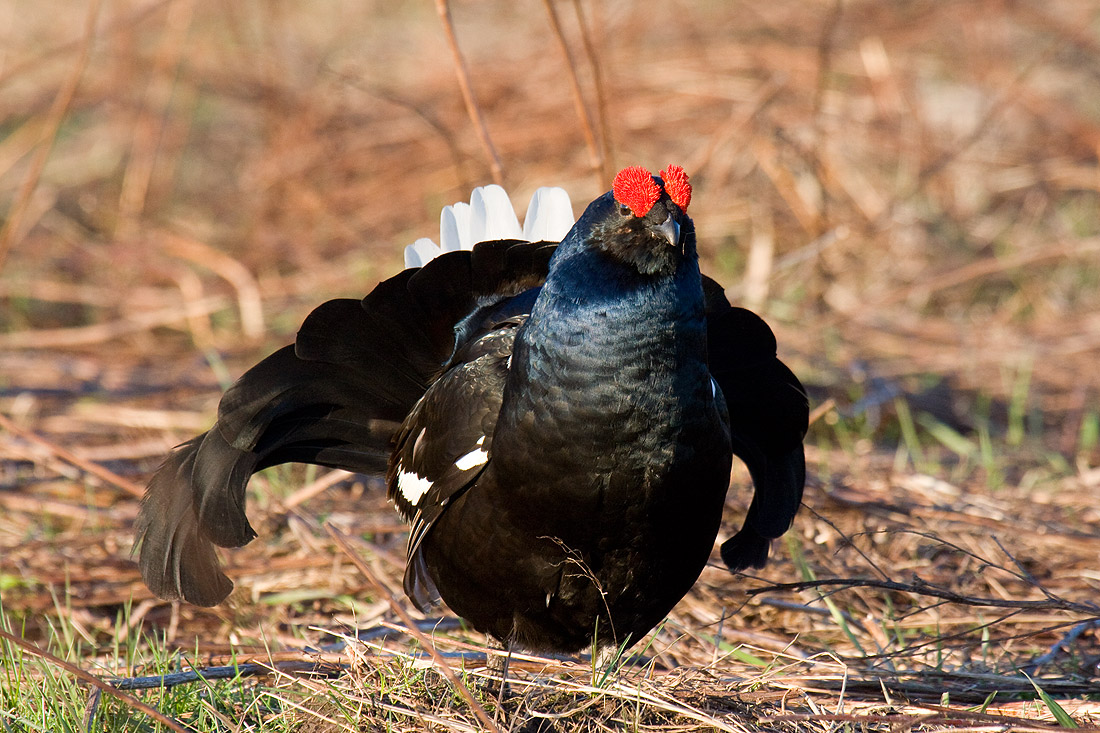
[386,317,524,610]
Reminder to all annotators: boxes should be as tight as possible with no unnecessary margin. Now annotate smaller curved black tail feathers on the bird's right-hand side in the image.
[704,277,810,570]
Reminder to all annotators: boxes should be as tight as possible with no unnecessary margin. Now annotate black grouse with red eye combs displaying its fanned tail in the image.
[135,165,809,653]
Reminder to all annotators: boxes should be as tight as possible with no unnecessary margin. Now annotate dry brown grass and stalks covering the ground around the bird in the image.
[0,0,1100,731]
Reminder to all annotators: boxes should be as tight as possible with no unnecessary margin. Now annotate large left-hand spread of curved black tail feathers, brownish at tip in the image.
[135,241,553,605]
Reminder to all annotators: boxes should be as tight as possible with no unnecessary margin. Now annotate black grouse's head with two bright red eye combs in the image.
[578,165,695,275]
